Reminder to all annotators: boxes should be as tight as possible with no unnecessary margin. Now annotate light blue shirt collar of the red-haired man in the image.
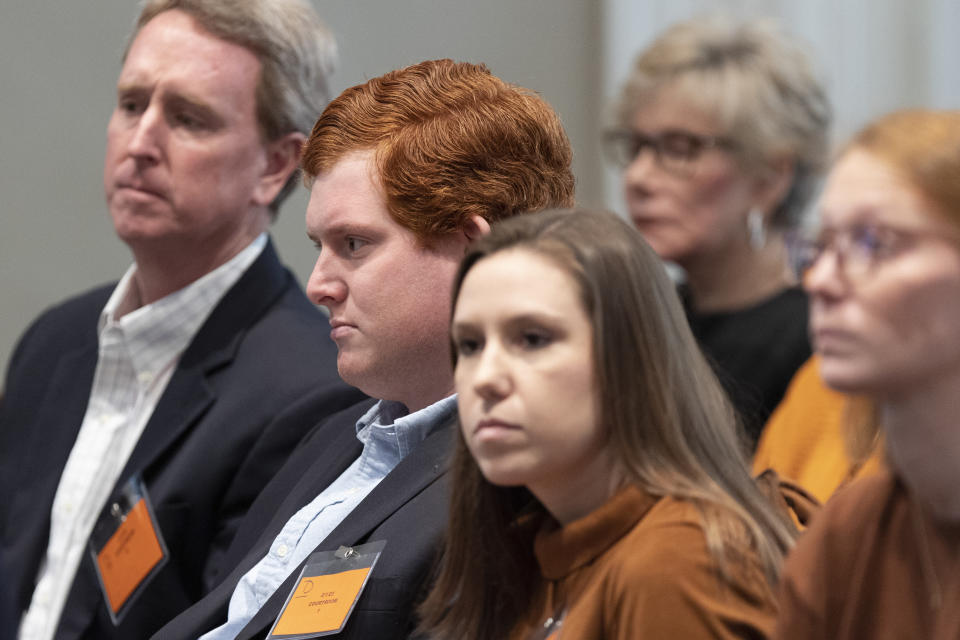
[357,394,457,458]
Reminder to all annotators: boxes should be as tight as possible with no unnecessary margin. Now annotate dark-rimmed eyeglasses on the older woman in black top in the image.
[603,129,736,175]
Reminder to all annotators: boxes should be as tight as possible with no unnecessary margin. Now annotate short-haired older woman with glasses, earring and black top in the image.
[605,20,830,450]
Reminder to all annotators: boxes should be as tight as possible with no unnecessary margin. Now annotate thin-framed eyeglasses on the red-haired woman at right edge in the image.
[794,223,960,280]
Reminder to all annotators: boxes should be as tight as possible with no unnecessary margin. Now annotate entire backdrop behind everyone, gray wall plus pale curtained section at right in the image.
[0,0,960,380]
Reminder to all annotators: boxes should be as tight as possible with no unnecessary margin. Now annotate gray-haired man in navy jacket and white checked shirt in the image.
[0,0,362,640]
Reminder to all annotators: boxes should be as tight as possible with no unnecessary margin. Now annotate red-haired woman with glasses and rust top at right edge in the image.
[778,111,960,640]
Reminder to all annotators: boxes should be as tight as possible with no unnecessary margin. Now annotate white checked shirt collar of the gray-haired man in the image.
[98,233,267,377]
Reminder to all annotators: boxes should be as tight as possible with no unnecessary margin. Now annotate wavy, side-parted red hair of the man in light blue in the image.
[301,60,574,243]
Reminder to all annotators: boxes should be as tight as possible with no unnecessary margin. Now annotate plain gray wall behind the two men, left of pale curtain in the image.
[0,0,602,376]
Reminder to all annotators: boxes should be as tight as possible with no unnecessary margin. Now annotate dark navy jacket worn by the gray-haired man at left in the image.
[0,244,363,640]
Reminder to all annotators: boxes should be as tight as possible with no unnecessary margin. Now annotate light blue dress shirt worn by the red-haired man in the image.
[200,396,456,640]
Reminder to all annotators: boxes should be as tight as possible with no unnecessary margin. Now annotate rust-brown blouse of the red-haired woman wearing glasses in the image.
[776,470,960,640]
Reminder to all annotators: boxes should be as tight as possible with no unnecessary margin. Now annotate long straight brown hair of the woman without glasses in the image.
[421,210,795,640]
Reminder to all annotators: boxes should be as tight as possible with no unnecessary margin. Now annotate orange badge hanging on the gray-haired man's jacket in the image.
[90,476,169,625]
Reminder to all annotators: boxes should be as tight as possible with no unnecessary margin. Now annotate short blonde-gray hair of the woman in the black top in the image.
[615,18,831,228]
